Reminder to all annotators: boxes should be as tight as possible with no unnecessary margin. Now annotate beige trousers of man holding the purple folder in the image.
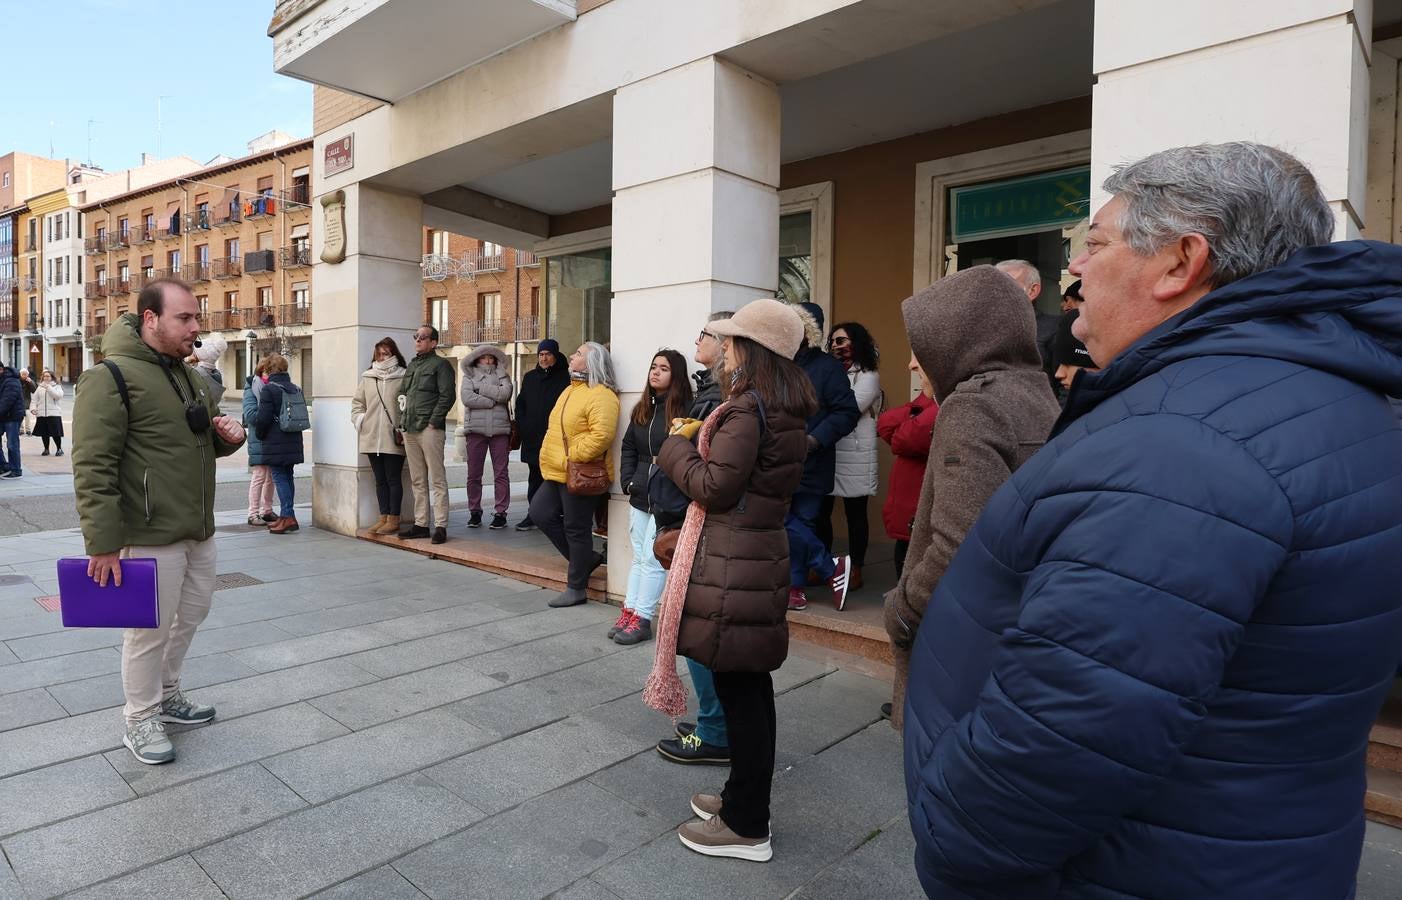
[122,538,219,722]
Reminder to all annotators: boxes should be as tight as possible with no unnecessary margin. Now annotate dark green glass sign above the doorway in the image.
[949,167,1091,244]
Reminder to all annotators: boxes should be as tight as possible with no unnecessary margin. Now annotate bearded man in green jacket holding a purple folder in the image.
[73,279,244,765]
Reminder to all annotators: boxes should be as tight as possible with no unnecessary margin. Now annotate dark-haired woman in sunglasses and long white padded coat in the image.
[817,322,882,590]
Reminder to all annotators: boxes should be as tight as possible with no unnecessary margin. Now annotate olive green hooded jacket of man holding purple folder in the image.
[73,313,241,555]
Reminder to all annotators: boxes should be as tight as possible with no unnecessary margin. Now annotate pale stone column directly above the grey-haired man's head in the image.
[1091,0,1373,240]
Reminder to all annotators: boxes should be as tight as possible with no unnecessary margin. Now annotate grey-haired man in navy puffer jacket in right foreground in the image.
[906,143,1402,900]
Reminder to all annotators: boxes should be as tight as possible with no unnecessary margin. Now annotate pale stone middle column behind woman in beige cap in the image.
[608,57,780,596]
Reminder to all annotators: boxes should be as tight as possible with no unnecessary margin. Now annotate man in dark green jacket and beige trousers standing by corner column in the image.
[400,325,457,544]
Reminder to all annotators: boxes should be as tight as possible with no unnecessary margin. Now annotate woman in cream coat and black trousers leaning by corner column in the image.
[351,338,405,534]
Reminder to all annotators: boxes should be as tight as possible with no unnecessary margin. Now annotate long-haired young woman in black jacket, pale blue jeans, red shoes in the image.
[619,349,691,645]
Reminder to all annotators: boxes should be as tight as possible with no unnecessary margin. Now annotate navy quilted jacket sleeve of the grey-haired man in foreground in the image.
[911,415,1293,882]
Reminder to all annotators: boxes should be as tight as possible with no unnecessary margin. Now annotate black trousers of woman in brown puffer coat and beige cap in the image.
[712,671,775,837]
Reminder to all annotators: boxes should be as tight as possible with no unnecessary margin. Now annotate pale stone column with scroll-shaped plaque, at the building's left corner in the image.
[311,184,423,534]
